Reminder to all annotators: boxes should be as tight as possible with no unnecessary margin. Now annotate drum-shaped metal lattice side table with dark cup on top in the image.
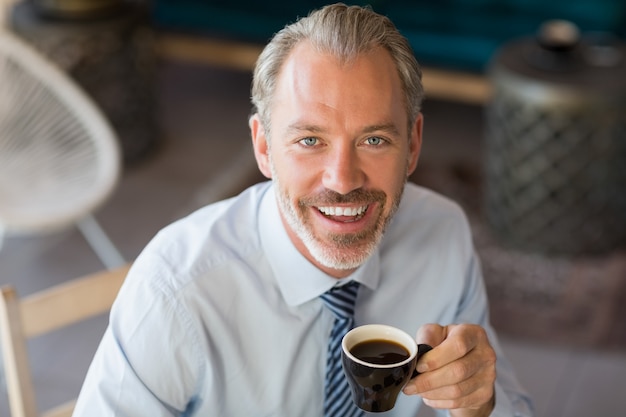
[486,21,626,255]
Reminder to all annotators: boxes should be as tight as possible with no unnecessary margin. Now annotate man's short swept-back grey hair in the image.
[252,3,424,135]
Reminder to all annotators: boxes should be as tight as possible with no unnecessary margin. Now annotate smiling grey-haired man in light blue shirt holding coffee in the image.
[74,4,530,417]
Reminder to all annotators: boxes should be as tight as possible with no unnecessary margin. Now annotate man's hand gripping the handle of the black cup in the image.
[404,324,496,417]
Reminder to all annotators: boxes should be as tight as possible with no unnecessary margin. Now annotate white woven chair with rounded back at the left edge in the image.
[0,27,124,268]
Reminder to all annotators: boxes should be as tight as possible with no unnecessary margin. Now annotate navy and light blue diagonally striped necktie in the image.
[320,281,363,417]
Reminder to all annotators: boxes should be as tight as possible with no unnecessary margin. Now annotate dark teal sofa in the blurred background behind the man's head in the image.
[152,0,626,72]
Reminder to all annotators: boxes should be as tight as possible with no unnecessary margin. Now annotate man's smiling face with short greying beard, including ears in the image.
[251,42,422,277]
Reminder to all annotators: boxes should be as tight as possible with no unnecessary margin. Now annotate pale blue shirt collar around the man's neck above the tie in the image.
[259,183,380,306]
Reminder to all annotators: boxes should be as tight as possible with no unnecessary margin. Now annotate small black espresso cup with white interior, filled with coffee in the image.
[341,324,432,413]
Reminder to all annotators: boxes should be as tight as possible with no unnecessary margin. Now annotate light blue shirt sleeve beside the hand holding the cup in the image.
[457,253,534,417]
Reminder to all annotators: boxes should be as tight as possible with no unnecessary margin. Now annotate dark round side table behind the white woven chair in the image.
[9,1,158,163]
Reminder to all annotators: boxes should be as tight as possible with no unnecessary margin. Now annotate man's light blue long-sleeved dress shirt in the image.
[74,182,528,417]
